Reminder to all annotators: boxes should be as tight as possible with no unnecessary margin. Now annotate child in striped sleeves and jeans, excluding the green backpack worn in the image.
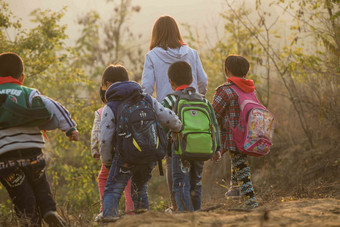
[162,61,220,211]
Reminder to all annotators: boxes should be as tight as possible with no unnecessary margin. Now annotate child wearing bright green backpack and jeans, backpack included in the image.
[162,61,221,211]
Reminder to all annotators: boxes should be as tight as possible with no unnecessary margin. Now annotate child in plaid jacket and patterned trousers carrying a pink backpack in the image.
[212,55,274,209]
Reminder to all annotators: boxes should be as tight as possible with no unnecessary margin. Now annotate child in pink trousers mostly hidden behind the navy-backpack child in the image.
[91,88,134,221]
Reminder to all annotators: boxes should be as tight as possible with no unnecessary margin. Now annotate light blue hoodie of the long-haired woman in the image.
[142,45,208,102]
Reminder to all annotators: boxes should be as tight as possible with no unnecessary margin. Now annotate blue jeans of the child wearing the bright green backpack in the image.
[172,152,204,211]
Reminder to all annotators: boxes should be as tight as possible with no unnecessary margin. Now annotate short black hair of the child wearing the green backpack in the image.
[168,61,192,86]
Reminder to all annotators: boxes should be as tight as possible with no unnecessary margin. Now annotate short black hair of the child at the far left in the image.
[0,52,24,79]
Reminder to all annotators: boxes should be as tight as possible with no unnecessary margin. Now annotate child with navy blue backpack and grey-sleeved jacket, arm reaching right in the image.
[100,65,182,222]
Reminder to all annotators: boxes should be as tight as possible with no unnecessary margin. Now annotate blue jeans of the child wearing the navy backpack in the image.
[103,157,156,217]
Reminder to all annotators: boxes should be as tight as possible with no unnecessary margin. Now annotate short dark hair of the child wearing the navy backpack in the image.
[102,65,129,84]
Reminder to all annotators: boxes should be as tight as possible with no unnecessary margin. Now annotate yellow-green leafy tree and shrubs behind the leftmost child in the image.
[0,0,100,223]
